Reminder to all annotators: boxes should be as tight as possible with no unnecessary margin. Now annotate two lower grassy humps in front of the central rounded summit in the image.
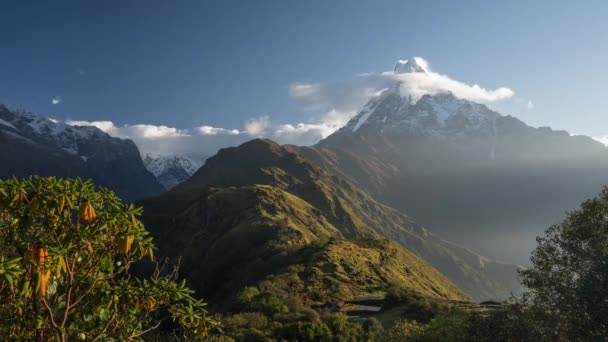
[144,185,467,307]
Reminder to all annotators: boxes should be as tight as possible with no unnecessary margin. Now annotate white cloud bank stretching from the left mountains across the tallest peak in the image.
[68,57,512,157]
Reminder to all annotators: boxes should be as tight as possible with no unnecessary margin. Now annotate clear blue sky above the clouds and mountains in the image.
[0,0,608,154]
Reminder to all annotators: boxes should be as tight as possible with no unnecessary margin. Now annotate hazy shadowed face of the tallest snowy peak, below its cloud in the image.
[291,87,608,264]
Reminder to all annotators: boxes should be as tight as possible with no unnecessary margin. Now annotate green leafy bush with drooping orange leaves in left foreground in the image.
[0,177,215,341]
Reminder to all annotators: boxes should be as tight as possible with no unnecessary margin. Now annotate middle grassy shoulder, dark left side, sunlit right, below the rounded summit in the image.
[144,186,340,299]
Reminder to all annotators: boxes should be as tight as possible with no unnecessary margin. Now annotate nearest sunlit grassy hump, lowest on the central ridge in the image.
[282,239,469,300]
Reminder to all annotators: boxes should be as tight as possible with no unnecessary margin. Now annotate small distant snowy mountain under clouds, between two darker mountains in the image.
[143,153,203,190]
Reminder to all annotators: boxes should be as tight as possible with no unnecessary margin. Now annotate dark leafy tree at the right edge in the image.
[521,188,608,340]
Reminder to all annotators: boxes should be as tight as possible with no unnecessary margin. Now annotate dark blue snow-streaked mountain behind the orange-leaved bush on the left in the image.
[0,105,163,201]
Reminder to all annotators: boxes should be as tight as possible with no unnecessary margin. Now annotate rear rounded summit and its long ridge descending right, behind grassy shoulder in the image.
[143,139,518,299]
